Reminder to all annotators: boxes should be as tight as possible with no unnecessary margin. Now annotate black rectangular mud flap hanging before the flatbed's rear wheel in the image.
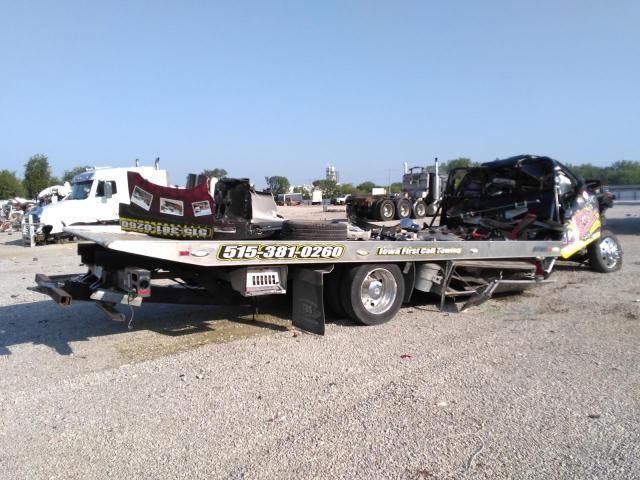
[292,266,333,335]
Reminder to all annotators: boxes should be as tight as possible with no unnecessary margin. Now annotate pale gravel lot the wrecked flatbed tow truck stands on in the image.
[0,205,640,479]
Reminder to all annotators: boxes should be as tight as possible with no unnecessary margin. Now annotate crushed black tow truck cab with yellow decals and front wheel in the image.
[440,155,622,272]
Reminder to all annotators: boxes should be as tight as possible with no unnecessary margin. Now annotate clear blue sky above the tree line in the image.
[0,0,640,187]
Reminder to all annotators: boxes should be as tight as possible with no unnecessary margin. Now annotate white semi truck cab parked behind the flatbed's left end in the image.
[31,161,169,243]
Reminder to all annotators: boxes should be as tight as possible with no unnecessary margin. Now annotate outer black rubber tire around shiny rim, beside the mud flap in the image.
[340,263,405,325]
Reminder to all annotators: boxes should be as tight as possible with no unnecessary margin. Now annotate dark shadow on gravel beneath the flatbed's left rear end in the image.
[0,301,291,356]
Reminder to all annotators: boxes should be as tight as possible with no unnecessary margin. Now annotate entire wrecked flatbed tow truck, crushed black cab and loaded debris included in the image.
[36,156,622,334]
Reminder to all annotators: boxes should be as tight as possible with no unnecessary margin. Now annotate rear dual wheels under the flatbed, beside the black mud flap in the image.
[326,264,405,325]
